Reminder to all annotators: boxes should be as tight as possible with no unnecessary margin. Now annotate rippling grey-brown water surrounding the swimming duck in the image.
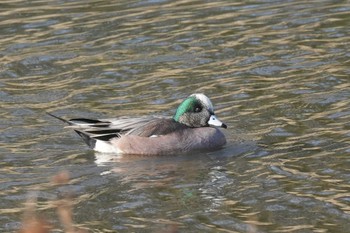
[0,0,350,232]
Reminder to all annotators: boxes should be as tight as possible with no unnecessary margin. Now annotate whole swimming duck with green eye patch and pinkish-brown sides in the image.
[48,94,227,155]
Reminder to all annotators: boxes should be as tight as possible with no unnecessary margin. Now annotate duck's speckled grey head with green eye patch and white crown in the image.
[173,94,227,128]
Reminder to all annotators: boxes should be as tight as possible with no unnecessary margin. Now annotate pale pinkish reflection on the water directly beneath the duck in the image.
[95,142,255,189]
